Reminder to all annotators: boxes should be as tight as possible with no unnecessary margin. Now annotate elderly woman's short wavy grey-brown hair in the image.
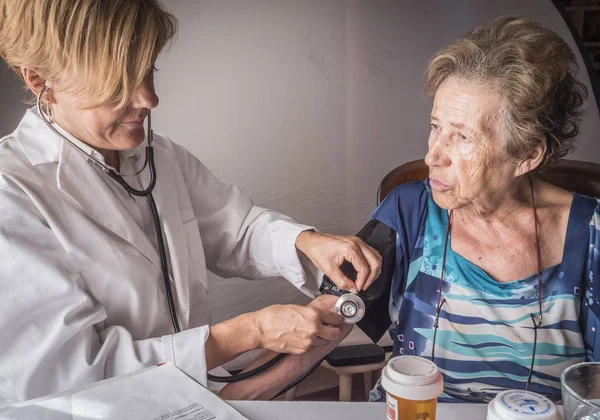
[425,16,587,168]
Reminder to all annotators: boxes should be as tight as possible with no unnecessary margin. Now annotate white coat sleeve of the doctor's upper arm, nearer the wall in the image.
[172,143,320,297]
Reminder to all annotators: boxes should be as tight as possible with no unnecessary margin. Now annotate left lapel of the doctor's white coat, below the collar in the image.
[57,141,160,270]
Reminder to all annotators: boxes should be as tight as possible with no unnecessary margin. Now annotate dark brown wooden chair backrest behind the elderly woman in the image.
[377,159,600,203]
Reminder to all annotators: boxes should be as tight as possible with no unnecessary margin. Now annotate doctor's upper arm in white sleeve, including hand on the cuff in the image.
[172,143,381,297]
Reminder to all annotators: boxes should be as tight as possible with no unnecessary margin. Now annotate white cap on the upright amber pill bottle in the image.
[381,356,444,401]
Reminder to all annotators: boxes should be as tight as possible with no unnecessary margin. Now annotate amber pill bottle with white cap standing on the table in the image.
[381,356,444,420]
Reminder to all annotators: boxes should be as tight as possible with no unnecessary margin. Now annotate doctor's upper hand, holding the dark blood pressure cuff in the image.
[296,230,382,293]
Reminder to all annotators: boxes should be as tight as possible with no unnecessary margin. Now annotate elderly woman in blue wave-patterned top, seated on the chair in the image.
[360,18,600,402]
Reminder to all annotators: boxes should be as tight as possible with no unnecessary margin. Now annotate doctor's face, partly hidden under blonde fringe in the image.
[52,71,158,150]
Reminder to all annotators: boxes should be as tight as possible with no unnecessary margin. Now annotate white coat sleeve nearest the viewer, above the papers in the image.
[0,188,209,406]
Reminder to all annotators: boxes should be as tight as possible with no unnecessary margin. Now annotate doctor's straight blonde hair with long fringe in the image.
[0,0,177,108]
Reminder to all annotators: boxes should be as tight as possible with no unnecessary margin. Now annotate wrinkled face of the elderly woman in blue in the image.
[425,76,517,210]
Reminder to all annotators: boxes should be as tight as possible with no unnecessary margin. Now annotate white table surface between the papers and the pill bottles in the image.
[228,401,487,420]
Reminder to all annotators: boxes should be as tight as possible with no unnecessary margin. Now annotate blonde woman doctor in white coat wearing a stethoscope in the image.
[0,0,380,406]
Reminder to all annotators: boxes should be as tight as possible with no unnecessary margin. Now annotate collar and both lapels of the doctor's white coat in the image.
[15,108,190,328]
